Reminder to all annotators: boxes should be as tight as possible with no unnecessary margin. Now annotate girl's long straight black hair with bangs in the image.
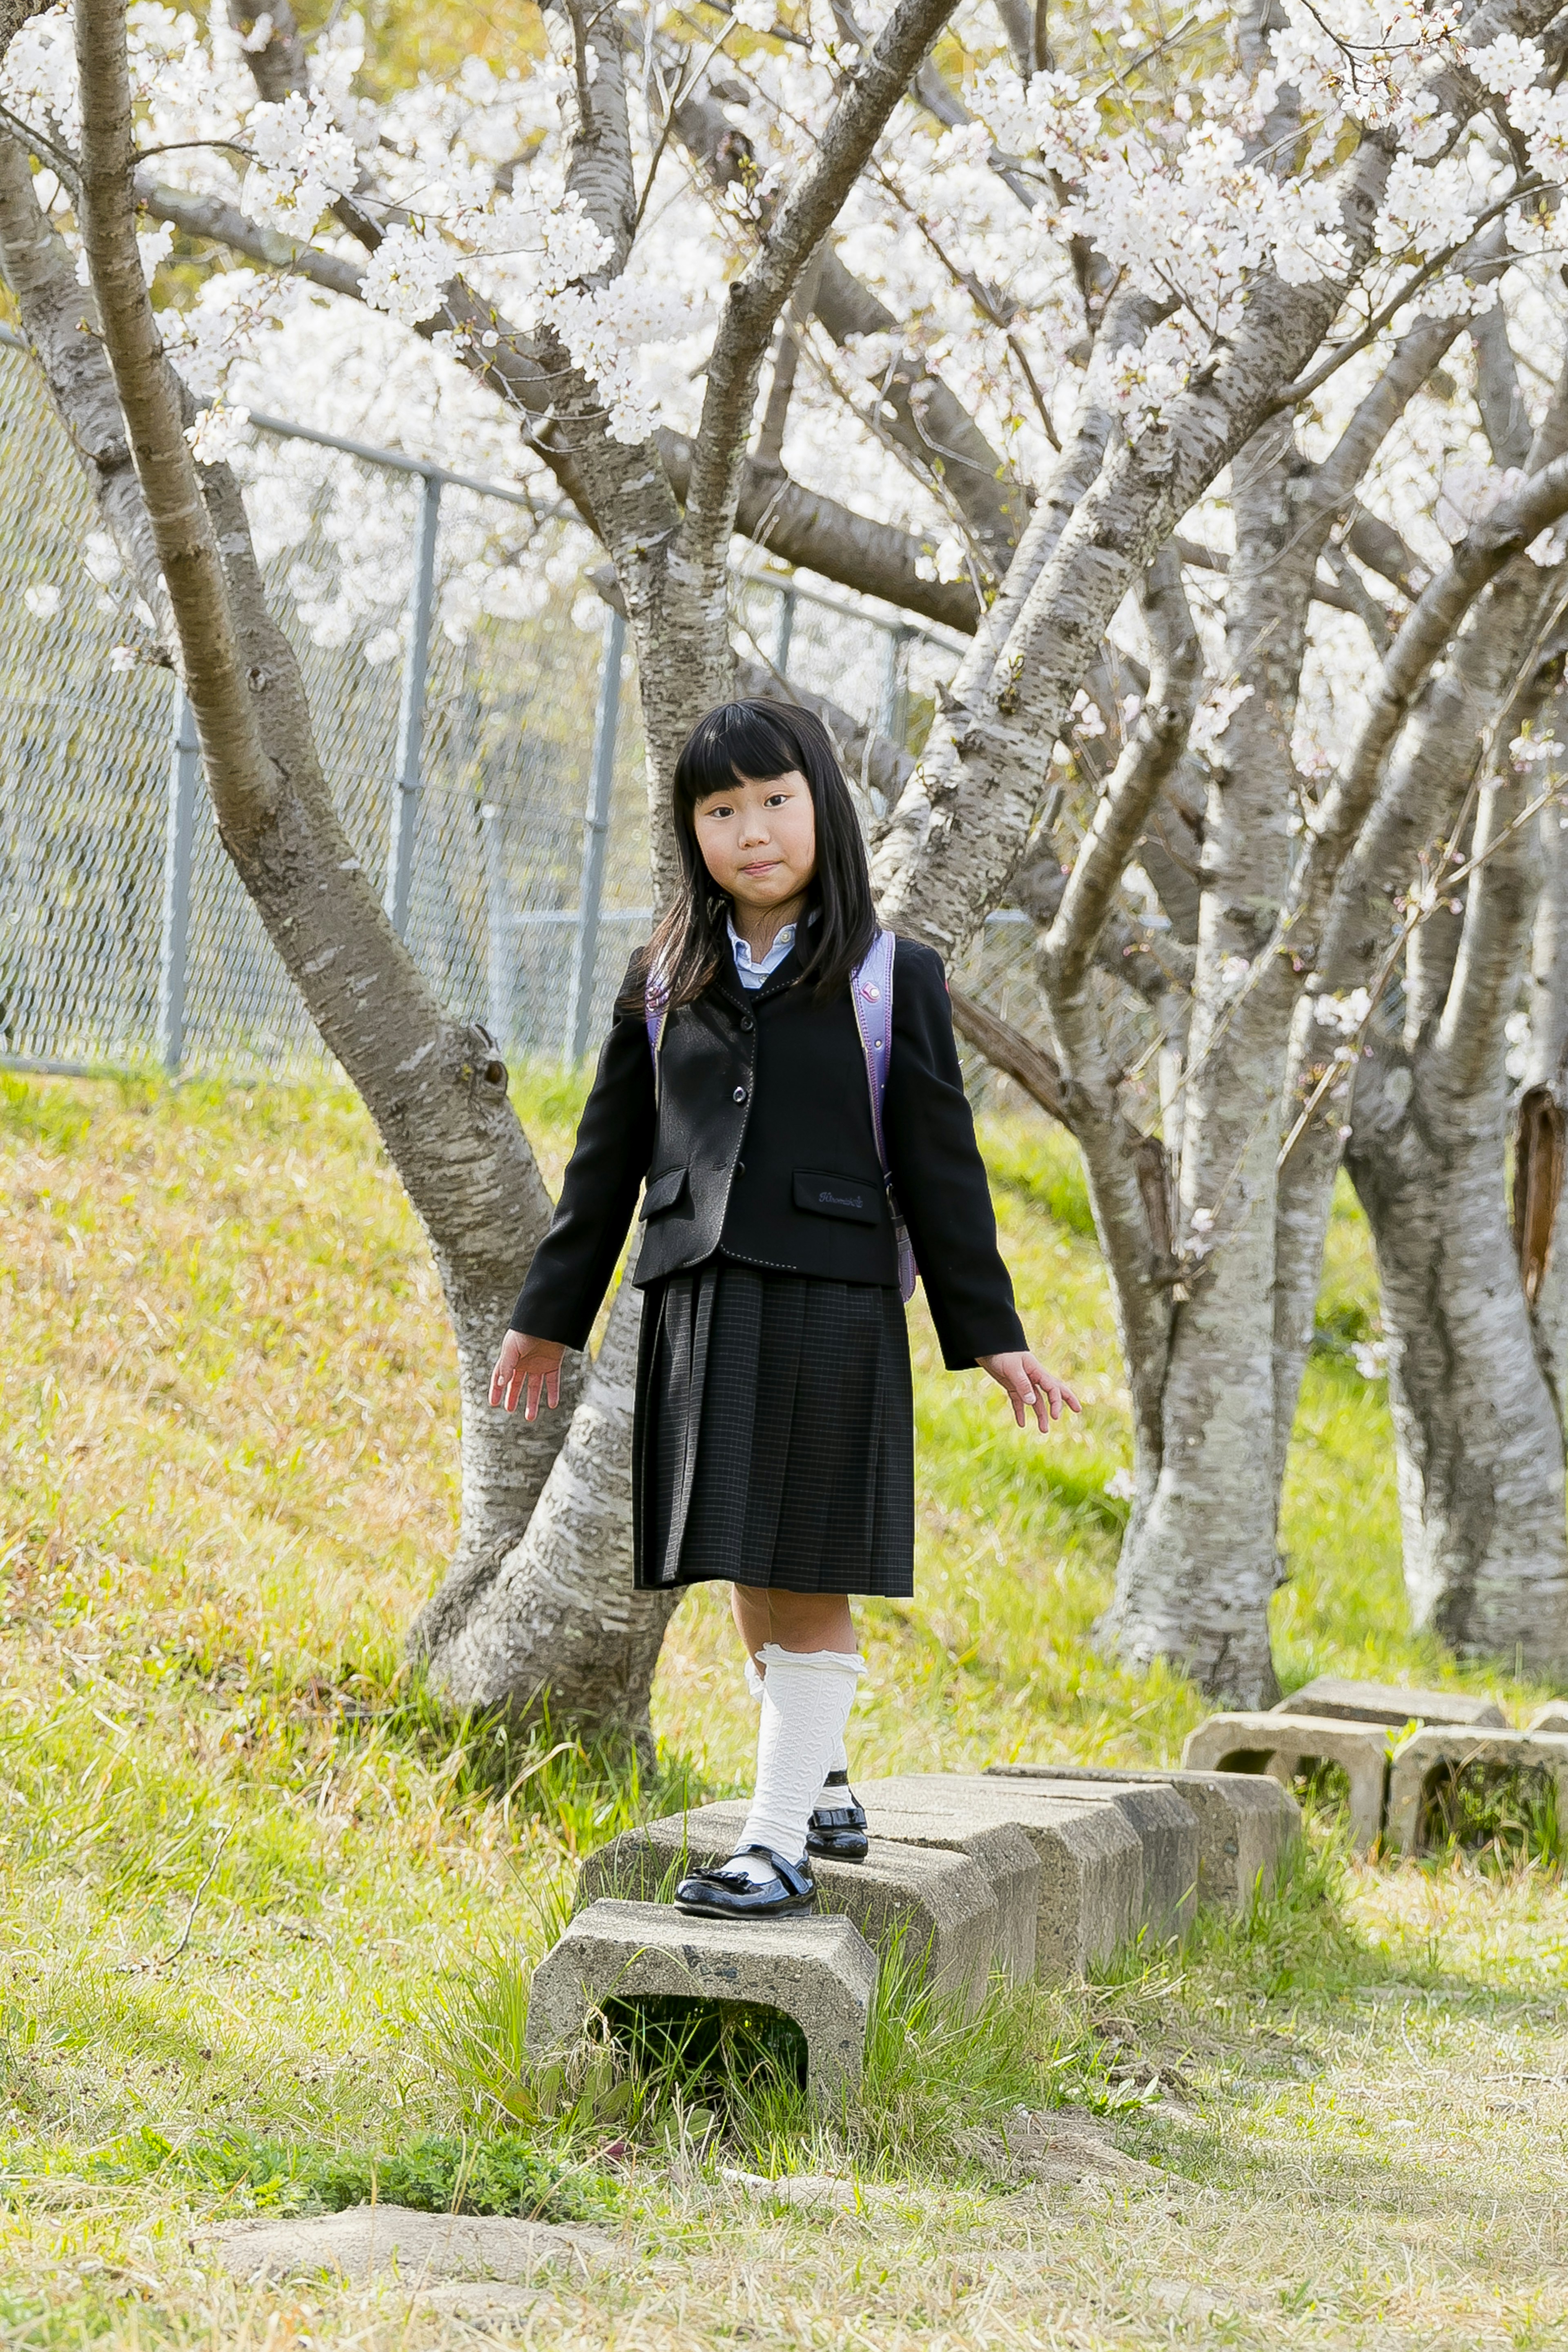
[633,701,877,1009]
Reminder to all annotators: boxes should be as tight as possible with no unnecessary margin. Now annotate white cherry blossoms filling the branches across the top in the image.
[0,0,1568,837]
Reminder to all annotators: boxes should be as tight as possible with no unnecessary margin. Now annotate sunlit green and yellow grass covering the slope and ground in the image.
[0,1072,1568,2352]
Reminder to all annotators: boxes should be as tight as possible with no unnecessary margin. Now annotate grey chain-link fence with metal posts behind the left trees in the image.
[0,337,957,1075]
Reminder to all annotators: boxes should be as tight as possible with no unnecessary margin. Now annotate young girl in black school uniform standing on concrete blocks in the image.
[491,701,1079,1917]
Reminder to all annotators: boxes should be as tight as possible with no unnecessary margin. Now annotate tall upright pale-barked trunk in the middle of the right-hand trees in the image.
[1105,419,1316,1705]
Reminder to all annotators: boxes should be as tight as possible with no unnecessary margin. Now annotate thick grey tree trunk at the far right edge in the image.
[1347,762,1568,1672]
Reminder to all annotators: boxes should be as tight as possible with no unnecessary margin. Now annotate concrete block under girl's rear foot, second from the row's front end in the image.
[578,1804,999,2006]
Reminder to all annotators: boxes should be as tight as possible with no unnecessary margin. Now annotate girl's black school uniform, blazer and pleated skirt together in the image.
[512,939,1025,1597]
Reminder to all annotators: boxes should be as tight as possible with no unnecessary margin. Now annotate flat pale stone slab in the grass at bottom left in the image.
[212,2206,614,2286]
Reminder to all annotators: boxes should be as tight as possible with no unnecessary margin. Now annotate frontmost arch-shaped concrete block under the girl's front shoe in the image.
[527,1900,877,2096]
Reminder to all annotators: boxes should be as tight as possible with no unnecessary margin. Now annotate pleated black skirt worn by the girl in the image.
[633,1258,915,1599]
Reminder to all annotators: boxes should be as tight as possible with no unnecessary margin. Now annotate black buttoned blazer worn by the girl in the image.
[512,939,1025,1371]
